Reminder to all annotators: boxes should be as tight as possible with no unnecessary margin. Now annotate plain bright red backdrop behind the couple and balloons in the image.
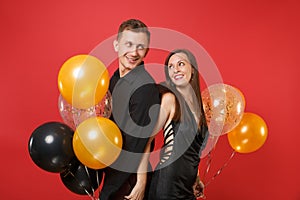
[0,0,300,200]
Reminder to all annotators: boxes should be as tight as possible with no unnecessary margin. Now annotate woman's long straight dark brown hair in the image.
[165,49,207,127]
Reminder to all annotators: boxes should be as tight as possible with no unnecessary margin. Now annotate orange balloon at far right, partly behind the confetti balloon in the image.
[227,113,268,153]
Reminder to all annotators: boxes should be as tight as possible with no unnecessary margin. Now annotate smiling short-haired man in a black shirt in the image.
[100,19,160,200]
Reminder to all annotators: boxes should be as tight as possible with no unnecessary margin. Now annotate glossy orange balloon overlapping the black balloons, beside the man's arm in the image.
[73,117,123,169]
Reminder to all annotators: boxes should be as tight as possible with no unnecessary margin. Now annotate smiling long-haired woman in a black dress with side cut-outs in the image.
[148,49,208,200]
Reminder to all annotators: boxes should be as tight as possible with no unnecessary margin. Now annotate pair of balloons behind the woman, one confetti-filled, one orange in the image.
[201,83,268,154]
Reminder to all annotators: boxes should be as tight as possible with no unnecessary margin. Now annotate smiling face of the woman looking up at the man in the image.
[168,53,193,87]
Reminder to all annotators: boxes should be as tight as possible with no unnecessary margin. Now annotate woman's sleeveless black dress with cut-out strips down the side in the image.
[148,95,208,200]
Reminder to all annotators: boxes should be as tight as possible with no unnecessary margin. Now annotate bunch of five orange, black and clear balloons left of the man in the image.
[28,55,123,198]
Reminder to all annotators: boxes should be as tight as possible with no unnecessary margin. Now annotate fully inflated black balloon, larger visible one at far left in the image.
[28,122,75,173]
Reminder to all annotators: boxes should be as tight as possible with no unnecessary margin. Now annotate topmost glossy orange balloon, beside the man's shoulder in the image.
[58,55,109,109]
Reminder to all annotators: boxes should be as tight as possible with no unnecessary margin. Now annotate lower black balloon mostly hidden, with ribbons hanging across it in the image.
[60,161,103,196]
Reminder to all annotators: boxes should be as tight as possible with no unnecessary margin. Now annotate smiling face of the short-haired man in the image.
[114,30,149,77]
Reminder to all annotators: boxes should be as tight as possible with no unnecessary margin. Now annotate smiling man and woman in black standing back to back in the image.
[100,19,208,200]
